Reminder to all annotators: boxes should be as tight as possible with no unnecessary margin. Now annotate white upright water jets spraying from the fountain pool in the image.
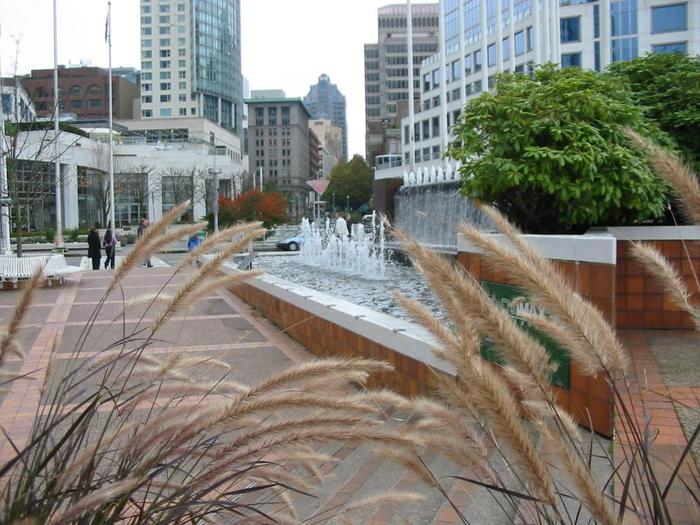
[298,214,387,279]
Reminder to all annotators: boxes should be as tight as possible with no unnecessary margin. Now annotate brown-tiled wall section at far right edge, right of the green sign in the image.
[615,239,700,330]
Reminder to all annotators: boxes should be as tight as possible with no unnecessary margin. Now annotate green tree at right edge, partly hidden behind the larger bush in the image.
[608,53,700,171]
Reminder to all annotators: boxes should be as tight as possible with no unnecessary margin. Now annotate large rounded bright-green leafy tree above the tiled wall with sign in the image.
[448,65,670,233]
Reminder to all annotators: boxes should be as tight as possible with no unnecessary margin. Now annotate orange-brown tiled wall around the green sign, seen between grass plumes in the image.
[457,252,615,436]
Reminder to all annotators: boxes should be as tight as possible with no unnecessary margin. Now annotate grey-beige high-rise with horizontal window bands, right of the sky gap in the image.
[364,4,440,166]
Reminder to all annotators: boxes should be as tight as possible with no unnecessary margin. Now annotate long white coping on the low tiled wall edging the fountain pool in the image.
[221,263,456,375]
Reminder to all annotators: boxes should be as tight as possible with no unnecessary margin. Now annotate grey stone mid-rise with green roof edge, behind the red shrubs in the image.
[246,90,318,218]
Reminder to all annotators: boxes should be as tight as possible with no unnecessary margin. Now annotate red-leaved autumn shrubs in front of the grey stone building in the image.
[216,190,287,227]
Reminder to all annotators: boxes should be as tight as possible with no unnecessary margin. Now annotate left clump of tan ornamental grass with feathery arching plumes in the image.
[0,203,423,525]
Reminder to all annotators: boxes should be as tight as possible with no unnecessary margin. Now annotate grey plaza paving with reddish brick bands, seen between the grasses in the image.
[0,265,700,525]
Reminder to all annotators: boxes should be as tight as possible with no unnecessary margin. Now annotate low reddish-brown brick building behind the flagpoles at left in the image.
[22,66,139,119]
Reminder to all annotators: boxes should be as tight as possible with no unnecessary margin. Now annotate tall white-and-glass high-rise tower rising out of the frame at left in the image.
[141,0,243,135]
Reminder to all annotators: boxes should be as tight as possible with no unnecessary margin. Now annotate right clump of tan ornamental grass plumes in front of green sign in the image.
[397,198,700,525]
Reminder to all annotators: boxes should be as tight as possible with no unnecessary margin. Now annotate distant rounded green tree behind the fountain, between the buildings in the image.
[322,155,374,208]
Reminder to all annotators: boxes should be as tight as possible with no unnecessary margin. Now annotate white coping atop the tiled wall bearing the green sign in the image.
[457,232,617,264]
